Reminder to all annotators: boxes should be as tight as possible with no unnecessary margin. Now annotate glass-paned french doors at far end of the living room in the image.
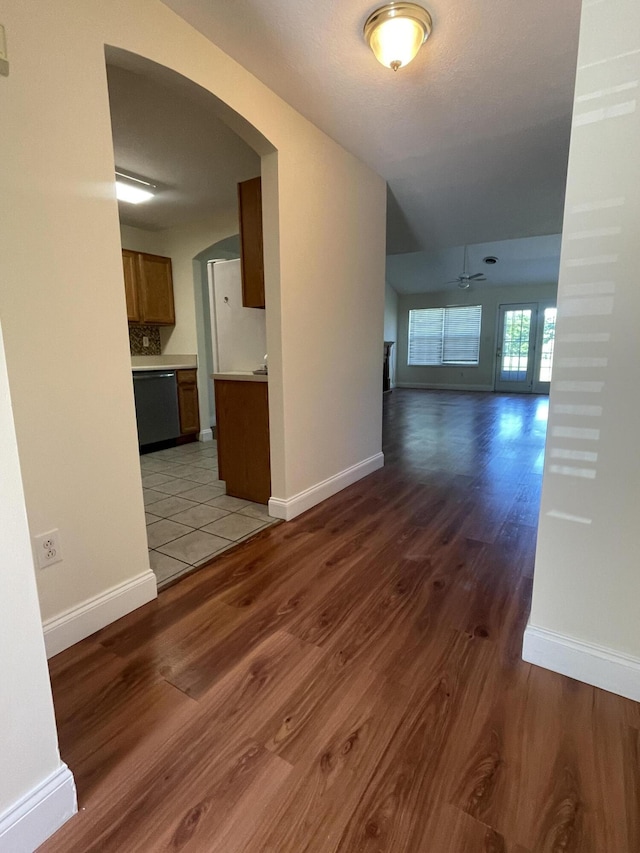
[495,302,556,394]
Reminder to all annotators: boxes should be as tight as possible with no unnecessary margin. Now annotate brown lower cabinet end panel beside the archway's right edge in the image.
[213,379,271,504]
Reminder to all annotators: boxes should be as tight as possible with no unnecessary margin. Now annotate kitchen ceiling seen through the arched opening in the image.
[107,57,260,231]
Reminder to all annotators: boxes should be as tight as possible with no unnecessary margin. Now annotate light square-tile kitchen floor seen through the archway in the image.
[140,441,277,587]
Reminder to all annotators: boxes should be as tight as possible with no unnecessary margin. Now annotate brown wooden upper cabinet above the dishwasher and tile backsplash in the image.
[122,249,176,326]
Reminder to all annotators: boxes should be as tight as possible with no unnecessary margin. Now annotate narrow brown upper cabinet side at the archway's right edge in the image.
[238,177,265,308]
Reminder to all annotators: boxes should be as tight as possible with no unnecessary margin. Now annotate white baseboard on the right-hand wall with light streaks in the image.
[522,625,640,702]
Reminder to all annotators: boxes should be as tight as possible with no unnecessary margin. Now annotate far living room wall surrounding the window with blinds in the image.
[396,284,557,391]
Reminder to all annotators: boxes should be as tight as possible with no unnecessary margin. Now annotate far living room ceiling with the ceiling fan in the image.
[387,234,561,294]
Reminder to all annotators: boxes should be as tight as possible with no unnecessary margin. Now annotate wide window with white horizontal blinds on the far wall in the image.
[407,305,482,365]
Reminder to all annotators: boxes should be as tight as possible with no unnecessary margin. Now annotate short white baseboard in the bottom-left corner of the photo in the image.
[0,764,78,853]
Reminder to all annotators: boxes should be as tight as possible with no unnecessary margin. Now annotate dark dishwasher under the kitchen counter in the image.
[133,370,180,447]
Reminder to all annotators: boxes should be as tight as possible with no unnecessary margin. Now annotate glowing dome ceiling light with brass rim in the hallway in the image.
[364,3,433,71]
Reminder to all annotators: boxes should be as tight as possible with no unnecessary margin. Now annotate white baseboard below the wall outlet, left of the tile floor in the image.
[42,569,158,658]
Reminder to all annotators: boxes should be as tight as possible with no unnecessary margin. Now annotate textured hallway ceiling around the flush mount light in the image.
[165,0,581,253]
